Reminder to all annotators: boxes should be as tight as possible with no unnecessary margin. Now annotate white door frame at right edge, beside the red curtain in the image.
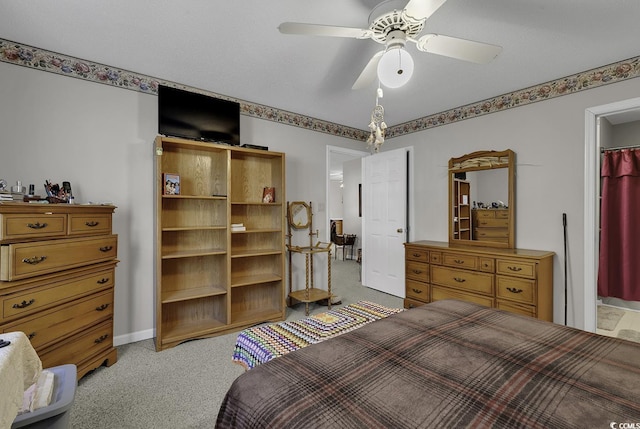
[583,98,640,332]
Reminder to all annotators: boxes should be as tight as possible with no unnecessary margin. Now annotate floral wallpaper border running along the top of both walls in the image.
[0,39,640,141]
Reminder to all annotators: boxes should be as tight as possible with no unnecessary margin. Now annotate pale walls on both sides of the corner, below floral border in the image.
[0,56,640,334]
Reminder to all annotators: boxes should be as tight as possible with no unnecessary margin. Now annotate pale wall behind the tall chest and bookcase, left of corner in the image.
[0,62,364,344]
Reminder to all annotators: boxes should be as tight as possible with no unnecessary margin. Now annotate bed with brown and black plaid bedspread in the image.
[216,300,640,429]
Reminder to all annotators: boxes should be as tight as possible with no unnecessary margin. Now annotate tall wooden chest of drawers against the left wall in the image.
[0,203,118,378]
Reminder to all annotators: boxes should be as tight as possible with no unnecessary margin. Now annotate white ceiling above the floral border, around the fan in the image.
[0,0,640,130]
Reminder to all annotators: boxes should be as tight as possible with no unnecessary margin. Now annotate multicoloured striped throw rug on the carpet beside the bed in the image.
[232,301,404,370]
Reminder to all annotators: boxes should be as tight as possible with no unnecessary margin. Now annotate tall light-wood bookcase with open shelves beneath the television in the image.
[155,137,286,351]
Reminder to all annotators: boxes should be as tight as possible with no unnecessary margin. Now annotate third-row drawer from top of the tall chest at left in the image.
[0,268,114,321]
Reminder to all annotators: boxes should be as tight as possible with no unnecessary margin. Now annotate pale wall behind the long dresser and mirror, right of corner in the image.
[383,79,640,328]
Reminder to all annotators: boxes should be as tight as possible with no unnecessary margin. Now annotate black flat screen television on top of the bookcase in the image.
[158,85,240,145]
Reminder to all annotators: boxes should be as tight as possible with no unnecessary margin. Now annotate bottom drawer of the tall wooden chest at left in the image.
[39,320,113,368]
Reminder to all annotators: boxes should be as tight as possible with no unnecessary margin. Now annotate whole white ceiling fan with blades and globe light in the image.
[278,0,502,89]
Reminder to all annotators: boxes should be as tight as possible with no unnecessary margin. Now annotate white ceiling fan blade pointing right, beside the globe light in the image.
[416,34,502,64]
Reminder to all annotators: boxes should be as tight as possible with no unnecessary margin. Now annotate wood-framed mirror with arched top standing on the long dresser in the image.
[449,149,516,249]
